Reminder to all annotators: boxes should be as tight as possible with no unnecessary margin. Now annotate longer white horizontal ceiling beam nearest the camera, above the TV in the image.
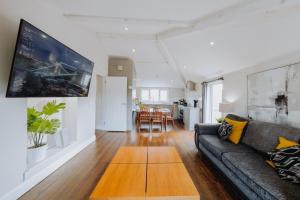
[63,13,190,27]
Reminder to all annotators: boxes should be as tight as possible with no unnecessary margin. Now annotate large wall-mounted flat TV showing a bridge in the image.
[6,19,94,97]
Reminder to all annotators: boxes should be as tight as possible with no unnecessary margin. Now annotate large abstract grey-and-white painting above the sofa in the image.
[248,63,300,128]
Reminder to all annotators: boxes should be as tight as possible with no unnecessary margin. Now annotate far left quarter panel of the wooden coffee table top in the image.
[111,146,147,164]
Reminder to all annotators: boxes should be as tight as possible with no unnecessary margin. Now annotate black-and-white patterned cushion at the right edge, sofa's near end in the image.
[269,145,300,184]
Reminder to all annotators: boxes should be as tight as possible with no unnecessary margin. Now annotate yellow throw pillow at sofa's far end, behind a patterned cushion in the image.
[225,118,248,144]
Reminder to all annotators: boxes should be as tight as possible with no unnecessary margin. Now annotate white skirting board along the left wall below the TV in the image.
[0,135,96,200]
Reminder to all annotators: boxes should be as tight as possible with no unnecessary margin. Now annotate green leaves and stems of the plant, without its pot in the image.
[27,100,66,148]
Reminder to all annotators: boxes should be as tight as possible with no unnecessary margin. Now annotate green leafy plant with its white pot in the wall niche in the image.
[27,100,66,164]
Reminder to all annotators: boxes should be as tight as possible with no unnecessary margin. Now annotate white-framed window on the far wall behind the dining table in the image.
[141,88,169,102]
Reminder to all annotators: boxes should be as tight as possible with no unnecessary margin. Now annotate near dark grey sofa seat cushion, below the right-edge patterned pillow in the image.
[222,152,300,200]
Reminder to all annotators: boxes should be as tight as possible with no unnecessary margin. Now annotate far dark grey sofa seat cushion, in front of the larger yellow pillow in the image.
[199,135,254,160]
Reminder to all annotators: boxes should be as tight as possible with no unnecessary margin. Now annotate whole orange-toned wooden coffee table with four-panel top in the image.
[90,147,200,200]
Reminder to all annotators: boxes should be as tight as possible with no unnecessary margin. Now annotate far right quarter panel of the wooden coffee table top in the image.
[148,146,182,163]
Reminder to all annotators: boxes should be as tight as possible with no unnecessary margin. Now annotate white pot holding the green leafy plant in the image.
[27,144,48,165]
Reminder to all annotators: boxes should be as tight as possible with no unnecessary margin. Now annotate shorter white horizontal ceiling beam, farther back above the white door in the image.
[96,32,157,41]
